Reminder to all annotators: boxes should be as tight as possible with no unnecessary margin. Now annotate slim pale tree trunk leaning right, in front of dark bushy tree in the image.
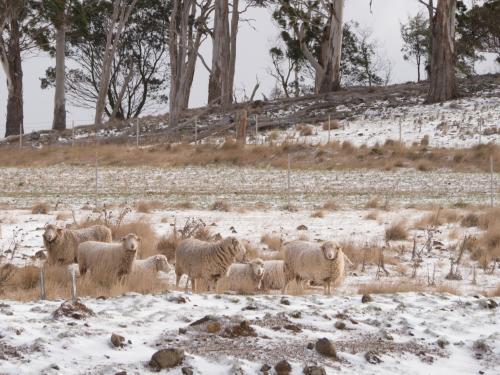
[94,0,137,125]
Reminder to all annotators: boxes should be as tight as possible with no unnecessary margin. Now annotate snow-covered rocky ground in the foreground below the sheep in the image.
[0,292,500,374]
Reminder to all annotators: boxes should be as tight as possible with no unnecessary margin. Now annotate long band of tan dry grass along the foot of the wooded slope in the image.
[0,140,500,172]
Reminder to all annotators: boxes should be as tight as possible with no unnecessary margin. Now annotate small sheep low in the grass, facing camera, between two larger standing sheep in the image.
[219,258,264,293]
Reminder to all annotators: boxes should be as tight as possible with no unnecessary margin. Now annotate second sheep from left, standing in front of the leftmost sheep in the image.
[77,233,141,277]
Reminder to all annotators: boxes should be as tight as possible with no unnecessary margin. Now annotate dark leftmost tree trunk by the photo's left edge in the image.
[2,17,24,137]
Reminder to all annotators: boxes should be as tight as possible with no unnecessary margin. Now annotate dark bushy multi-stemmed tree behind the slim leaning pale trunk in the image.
[42,0,170,119]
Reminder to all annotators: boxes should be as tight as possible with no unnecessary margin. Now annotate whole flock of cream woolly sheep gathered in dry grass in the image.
[38,224,349,294]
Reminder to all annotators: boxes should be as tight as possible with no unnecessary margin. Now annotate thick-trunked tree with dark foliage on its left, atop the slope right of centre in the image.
[273,0,344,93]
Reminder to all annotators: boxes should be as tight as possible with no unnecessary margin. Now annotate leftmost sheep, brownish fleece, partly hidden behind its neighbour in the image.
[42,224,111,265]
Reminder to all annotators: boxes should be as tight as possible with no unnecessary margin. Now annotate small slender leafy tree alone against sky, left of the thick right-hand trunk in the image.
[401,12,431,82]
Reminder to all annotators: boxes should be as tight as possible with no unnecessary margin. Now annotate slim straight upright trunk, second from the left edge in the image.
[52,21,66,130]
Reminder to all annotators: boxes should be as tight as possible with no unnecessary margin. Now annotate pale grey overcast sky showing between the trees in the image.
[0,0,500,136]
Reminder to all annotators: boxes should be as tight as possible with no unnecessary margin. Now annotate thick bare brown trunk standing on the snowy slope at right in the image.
[426,0,457,103]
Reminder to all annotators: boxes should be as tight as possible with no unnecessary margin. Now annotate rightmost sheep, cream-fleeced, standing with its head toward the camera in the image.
[283,241,345,295]
